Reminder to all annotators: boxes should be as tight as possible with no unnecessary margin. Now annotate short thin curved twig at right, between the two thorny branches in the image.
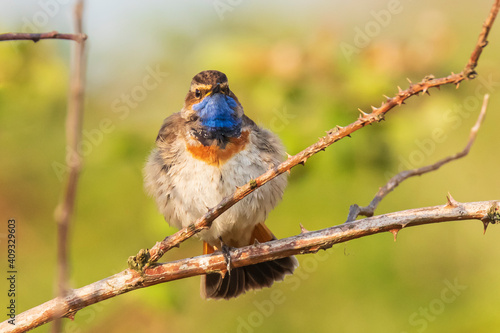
[346,94,489,222]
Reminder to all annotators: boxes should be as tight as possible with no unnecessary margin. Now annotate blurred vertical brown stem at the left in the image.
[52,0,85,333]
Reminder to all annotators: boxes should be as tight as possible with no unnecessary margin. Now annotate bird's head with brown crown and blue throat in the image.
[182,70,243,140]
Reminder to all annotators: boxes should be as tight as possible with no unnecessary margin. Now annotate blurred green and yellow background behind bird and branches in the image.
[0,0,500,333]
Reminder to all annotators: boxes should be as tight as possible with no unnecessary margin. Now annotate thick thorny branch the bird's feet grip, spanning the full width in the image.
[0,201,500,333]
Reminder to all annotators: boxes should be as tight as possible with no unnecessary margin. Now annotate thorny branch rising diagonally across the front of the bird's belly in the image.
[137,0,500,269]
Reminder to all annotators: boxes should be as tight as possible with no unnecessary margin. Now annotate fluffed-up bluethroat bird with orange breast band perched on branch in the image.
[144,70,298,299]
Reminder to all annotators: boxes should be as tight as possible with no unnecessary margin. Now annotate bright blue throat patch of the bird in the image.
[192,93,241,136]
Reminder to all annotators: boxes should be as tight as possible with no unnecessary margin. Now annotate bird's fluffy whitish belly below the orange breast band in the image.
[146,145,287,247]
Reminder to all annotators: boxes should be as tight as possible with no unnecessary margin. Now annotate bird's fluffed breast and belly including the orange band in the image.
[146,123,287,246]
